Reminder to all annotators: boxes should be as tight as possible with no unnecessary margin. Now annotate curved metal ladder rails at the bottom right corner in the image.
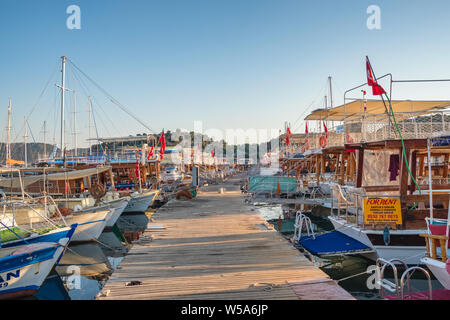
[376,258,433,300]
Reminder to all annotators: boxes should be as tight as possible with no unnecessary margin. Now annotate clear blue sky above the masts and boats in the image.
[0,0,450,146]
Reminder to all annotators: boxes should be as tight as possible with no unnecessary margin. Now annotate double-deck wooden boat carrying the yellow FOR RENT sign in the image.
[292,95,450,265]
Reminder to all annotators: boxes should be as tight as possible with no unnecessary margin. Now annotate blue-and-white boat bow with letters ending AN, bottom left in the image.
[0,224,77,299]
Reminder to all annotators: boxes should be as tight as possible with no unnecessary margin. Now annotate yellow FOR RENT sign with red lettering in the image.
[364,198,402,224]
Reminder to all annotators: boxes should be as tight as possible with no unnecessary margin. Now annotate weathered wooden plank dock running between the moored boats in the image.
[97,178,354,300]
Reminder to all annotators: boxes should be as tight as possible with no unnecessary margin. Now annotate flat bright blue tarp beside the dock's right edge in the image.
[299,231,372,256]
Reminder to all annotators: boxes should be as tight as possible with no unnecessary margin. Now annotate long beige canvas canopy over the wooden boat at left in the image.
[0,166,111,189]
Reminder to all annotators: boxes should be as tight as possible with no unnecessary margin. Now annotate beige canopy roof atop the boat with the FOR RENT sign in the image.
[305,99,450,121]
